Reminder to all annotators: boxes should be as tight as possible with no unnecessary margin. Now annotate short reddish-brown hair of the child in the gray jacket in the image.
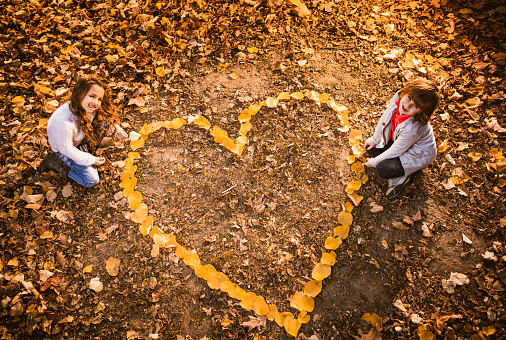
[399,79,440,125]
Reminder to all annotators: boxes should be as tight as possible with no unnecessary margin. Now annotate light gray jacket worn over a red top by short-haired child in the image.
[368,92,437,175]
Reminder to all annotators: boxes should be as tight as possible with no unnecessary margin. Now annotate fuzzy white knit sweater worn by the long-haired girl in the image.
[47,102,95,166]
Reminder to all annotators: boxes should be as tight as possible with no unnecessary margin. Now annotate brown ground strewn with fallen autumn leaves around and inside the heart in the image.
[0,0,506,340]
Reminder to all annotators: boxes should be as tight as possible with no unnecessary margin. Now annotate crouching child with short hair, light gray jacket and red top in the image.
[364,79,440,199]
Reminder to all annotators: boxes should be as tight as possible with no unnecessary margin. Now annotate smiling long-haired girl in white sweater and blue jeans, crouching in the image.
[38,76,128,187]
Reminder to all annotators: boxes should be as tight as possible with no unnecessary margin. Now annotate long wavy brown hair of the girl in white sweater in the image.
[70,76,119,145]
